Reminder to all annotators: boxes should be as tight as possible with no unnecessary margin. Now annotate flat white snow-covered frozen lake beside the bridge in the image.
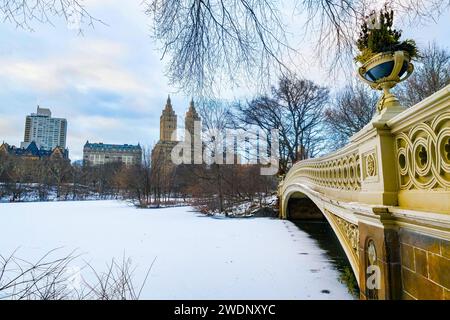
[0,201,352,299]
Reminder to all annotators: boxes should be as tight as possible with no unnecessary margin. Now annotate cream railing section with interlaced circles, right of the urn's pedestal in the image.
[387,90,450,213]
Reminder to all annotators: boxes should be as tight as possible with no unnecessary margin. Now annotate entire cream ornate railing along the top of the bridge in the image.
[280,85,450,213]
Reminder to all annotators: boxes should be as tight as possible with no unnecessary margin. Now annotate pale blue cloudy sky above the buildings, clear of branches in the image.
[0,0,450,160]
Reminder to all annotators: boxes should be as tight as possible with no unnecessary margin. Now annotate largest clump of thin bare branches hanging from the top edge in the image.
[146,0,289,94]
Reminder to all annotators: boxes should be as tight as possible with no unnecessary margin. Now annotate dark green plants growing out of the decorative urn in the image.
[355,6,419,64]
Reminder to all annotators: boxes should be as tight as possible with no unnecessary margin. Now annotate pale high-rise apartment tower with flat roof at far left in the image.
[21,106,67,150]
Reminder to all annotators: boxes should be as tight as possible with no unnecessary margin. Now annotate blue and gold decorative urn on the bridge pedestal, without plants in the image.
[358,51,414,112]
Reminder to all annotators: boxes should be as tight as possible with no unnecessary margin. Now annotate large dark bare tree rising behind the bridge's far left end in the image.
[236,74,329,174]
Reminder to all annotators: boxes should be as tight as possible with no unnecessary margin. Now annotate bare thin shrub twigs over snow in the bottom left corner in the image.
[0,248,156,300]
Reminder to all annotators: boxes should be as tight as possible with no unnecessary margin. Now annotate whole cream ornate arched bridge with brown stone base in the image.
[278,85,450,299]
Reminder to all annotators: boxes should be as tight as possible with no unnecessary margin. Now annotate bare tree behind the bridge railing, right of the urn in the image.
[398,43,450,107]
